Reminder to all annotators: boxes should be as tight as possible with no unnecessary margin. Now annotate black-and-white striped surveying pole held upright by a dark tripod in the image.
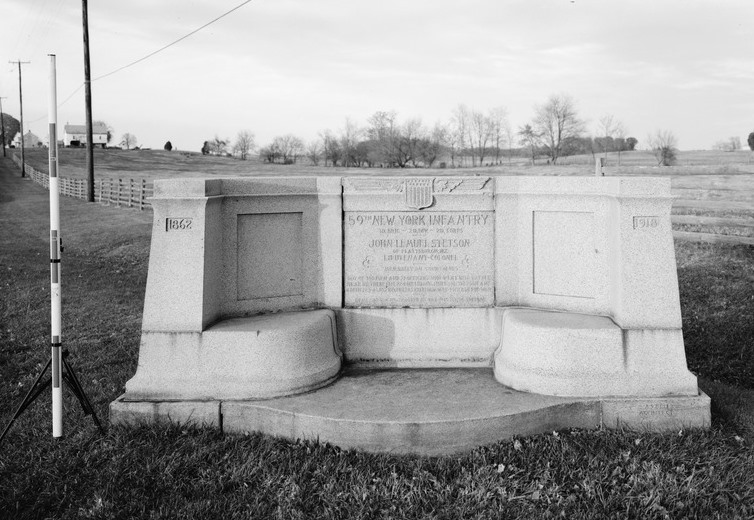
[48,54,63,437]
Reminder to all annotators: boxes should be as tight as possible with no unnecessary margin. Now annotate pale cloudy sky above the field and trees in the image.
[0,0,754,151]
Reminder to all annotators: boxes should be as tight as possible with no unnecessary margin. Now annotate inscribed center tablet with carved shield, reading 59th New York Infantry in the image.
[343,179,494,307]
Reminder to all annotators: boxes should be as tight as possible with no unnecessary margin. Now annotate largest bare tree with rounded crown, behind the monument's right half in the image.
[532,94,584,164]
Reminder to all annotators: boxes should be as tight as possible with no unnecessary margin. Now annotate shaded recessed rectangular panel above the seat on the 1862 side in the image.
[237,213,304,300]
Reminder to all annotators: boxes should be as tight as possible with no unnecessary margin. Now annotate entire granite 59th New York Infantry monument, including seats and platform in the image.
[110,175,710,455]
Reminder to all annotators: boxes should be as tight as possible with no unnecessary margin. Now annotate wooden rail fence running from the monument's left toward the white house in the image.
[11,154,154,210]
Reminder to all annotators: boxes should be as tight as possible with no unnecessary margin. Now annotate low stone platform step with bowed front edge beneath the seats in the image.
[110,367,710,455]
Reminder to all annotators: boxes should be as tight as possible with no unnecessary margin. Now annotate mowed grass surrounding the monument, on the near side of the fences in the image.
[0,159,754,519]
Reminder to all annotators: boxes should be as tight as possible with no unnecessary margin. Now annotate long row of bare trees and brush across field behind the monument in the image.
[202,94,638,168]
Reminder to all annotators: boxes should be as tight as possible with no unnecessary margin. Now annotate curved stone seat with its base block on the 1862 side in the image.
[124,309,341,401]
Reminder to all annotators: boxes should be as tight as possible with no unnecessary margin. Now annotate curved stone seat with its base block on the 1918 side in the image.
[494,309,698,397]
